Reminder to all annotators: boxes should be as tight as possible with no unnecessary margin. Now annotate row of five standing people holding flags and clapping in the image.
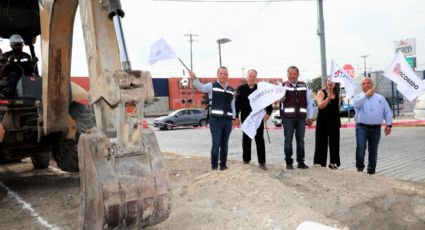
[189,66,393,174]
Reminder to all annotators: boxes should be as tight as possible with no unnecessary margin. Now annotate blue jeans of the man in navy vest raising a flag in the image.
[209,117,232,169]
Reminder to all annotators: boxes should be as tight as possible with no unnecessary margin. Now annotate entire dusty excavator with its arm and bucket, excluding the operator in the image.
[0,0,171,230]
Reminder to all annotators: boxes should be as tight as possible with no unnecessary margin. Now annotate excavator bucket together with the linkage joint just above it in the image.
[78,71,171,230]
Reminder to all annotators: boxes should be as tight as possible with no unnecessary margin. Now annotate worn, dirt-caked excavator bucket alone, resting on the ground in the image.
[78,128,171,229]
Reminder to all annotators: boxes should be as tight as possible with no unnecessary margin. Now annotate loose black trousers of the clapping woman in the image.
[314,125,341,167]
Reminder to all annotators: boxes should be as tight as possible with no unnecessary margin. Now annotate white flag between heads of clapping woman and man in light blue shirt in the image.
[329,60,359,99]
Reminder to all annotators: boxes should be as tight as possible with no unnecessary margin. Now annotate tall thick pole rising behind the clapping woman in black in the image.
[317,0,328,87]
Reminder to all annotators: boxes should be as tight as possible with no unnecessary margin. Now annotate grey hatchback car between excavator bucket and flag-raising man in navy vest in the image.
[153,108,208,130]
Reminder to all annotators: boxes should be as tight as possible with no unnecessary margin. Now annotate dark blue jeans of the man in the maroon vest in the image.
[282,118,305,165]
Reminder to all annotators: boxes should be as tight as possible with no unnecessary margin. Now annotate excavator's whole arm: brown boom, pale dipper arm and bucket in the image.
[40,0,171,229]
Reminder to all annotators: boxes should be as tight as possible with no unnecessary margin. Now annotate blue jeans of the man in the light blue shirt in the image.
[356,124,381,174]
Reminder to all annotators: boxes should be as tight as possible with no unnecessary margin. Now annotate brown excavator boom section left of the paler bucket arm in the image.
[39,0,78,135]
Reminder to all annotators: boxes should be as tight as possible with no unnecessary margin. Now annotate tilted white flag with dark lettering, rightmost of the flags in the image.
[384,50,425,101]
